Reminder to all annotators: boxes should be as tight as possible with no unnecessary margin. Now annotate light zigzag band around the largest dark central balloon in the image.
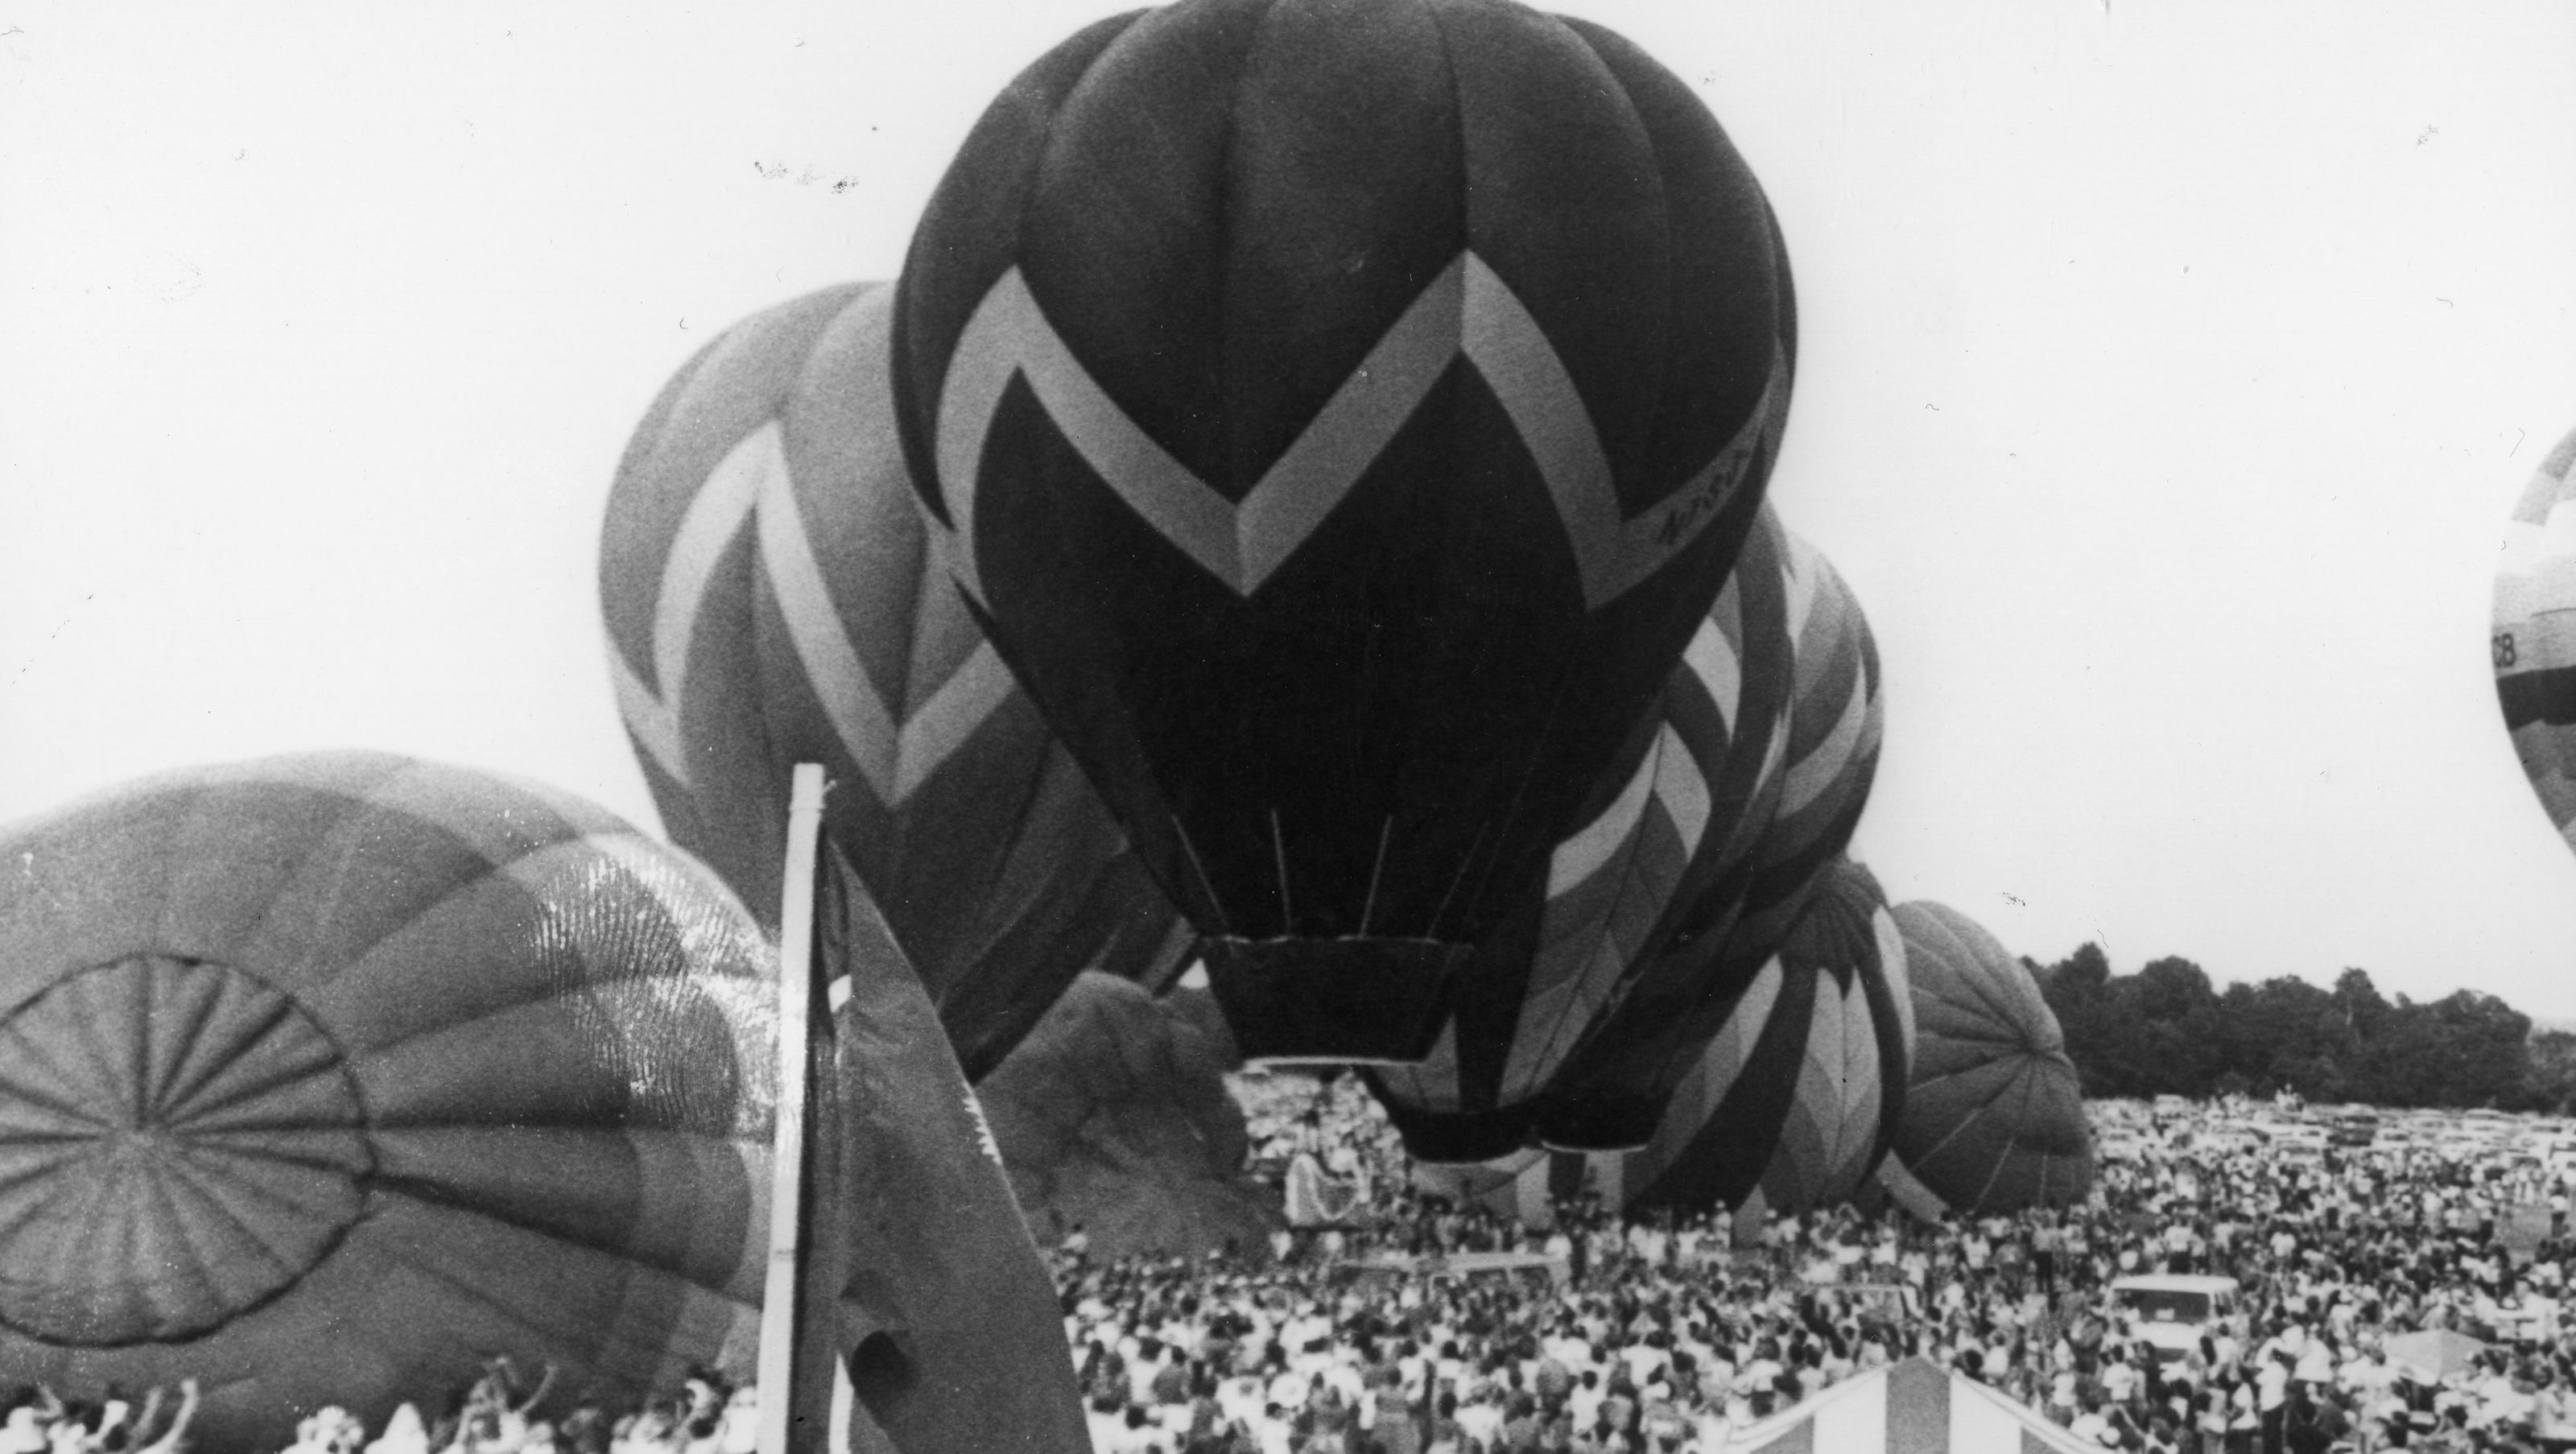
[935,253,1788,609]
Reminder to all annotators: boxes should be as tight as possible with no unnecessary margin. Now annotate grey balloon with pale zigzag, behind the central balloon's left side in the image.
[601,283,1187,1077]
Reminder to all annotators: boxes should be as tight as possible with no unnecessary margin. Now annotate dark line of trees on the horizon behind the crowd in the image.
[2022,944,2576,1113]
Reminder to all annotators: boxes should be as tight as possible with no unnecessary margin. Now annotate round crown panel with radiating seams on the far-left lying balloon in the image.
[0,954,374,1349]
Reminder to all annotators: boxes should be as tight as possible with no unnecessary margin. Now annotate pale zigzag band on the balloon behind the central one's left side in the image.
[608,418,1018,807]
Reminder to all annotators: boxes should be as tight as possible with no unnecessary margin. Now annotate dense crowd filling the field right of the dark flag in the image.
[1056,1080,2576,1454]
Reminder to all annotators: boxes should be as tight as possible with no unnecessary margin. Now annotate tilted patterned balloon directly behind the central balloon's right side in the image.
[1368,508,1793,1163]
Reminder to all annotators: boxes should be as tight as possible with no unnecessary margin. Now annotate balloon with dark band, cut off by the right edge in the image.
[2488,419,2576,849]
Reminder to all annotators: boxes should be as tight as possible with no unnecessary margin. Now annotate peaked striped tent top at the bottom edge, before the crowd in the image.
[1726,1359,2102,1454]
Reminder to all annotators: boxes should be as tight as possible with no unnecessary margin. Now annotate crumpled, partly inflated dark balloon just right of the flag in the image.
[976,972,1280,1258]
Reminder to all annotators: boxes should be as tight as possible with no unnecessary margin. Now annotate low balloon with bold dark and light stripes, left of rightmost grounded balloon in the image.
[1432,858,1914,1222]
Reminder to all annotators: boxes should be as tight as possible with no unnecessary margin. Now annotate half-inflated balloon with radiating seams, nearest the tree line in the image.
[1893,903,2095,1216]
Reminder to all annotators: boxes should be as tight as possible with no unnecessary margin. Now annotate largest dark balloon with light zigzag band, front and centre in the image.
[894,0,1795,1060]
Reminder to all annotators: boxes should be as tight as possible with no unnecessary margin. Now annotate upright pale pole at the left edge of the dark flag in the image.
[758,763,822,1454]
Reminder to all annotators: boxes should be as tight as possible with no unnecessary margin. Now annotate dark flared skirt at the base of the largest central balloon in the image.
[1200,936,1471,1064]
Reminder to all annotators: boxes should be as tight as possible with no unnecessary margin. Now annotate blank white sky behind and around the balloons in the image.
[0,0,2576,1016]
